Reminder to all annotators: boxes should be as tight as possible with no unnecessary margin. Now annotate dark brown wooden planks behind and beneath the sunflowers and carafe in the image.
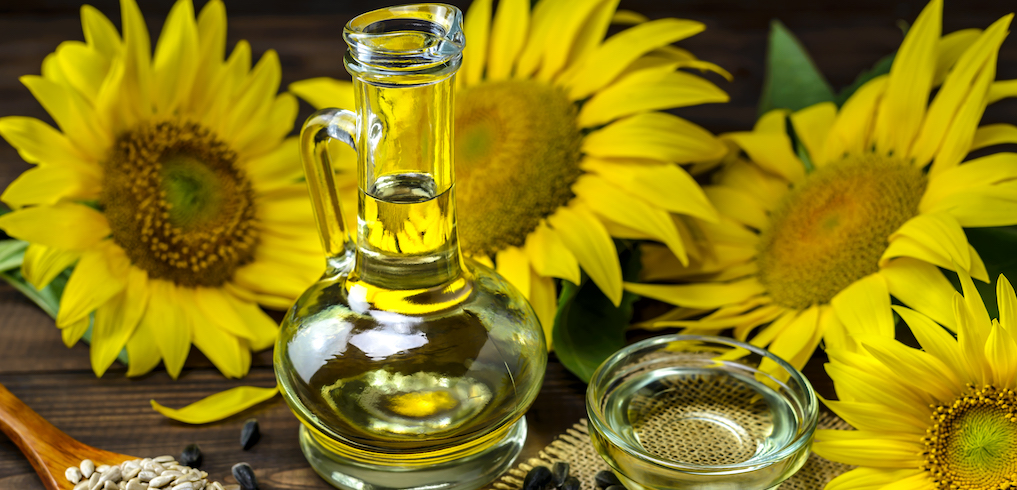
[0,0,1017,490]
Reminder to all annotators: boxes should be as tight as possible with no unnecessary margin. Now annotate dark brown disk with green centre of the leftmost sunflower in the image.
[100,122,258,287]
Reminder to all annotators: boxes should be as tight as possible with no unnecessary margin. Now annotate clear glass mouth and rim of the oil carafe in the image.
[343,3,466,75]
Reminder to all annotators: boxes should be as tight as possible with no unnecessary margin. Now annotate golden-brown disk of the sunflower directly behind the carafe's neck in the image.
[456,80,582,256]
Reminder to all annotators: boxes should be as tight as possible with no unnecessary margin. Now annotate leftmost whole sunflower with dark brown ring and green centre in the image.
[0,0,322,377]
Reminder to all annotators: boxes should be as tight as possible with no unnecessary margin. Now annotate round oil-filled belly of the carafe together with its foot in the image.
[275,258,547,490]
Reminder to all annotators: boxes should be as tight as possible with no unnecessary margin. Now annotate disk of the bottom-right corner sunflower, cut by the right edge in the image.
[923,386,1017,489]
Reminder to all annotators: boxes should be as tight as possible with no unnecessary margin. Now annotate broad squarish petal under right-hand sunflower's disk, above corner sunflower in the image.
[830,272,894,339]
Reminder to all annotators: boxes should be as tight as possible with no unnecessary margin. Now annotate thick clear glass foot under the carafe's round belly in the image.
[300,418,526,490]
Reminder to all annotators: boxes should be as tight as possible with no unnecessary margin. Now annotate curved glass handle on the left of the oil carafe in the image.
[300,109,357,266]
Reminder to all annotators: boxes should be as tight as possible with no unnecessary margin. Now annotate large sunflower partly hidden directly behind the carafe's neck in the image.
[290,0,728,339]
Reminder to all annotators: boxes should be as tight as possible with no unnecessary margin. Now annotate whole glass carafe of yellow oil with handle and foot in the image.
[275,4,547,490]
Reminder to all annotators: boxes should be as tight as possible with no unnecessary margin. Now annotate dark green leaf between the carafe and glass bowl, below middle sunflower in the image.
[552,242,641,382]
